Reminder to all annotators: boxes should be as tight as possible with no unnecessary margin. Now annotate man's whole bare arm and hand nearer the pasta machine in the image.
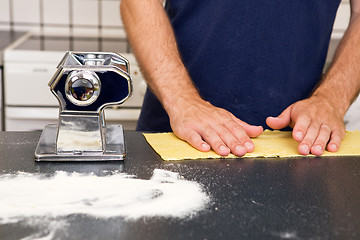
[121,0,263,156]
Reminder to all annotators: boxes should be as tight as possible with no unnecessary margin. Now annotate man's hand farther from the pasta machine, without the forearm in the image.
[266,96,345,156]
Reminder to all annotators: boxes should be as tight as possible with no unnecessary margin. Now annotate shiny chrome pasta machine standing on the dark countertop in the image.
[35,52,132,161]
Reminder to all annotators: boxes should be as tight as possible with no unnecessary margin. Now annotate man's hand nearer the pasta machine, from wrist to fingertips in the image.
[168,98,263,156]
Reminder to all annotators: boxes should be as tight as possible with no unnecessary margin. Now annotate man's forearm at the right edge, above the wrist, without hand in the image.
[313,9,360,115]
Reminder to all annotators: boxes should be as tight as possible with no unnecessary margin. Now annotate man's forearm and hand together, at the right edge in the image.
[266,0,360,155]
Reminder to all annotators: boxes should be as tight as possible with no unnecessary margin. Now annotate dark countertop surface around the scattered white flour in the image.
[0,132,360,240]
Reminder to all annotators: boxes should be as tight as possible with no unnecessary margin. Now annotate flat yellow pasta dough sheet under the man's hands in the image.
[144,130,360,161]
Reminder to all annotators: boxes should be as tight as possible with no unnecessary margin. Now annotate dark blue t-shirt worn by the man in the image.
[137,0,340,131]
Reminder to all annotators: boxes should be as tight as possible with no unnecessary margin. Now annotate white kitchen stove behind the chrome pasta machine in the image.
[4,33,146,131]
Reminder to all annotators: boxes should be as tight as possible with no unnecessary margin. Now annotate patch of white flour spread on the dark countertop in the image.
[0,169,209,224]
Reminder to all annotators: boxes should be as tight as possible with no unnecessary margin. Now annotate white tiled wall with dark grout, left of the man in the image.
[0,0,125,37]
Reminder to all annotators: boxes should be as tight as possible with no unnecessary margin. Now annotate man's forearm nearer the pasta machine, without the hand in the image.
[120,0,200,112]
